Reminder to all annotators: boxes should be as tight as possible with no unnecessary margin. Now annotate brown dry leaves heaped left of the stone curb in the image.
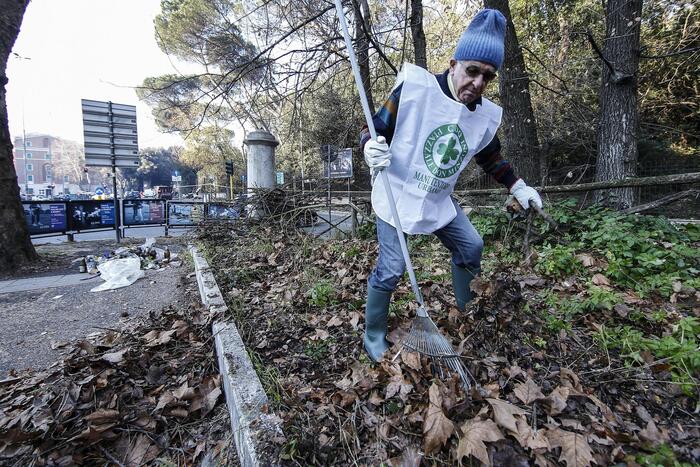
[0,277,236,466]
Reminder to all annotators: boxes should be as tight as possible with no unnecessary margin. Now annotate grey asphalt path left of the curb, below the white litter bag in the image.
[0,263,189,379]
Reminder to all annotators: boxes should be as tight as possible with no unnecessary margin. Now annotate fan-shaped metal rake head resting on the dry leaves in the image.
[401,309,474,394]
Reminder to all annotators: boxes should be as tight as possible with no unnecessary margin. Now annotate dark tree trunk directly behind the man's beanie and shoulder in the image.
[484,0,541,185]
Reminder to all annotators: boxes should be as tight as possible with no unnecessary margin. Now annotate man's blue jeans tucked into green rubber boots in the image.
[368,199,484,292]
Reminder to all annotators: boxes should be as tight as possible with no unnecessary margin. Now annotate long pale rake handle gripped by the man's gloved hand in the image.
[335,0,427,316]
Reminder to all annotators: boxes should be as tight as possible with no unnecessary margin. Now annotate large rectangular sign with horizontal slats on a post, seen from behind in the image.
[81,99,139,242]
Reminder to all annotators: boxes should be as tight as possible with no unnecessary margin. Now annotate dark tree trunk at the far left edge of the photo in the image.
[0,0,38,271]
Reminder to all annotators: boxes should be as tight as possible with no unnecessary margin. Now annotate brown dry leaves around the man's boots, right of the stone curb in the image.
[200,226,700,467]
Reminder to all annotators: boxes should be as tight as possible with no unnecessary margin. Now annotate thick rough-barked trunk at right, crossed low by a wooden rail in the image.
[595,0,642,209]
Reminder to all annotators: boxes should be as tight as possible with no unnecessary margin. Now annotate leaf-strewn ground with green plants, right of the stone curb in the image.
[199,203,700,466]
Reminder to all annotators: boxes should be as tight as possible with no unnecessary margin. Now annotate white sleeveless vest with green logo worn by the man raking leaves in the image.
[372,63,502,234]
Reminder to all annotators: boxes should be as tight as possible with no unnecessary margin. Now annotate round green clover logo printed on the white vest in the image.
[423,123,469,178]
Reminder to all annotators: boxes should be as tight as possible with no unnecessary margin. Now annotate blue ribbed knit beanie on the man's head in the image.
[454,9,506,69]
